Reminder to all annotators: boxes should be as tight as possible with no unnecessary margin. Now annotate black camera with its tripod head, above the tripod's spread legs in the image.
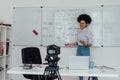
[45,45,60,67]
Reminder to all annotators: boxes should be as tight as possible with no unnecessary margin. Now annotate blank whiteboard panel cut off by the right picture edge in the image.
[103,5,120,46]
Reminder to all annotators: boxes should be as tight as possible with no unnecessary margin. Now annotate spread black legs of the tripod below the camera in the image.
[44,66,62,80]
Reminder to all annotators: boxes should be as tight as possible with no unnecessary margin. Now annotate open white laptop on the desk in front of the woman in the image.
[69,56,89,70]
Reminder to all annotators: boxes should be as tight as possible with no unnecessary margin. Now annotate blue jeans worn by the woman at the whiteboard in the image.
[76,45,90,80]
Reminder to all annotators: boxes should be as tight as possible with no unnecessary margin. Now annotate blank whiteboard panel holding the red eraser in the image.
[13,7,41,45]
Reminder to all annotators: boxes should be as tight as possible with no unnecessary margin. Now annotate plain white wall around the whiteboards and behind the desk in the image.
[0,0,120,80]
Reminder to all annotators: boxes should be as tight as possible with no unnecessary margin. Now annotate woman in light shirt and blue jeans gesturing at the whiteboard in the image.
[65,14,92,80]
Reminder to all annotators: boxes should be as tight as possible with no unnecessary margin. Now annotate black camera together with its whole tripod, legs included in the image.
[44,45,62,80]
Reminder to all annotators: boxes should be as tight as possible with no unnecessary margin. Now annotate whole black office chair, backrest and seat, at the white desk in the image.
[22,47,44,80]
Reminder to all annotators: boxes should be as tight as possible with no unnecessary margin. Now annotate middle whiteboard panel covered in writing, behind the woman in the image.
[42,7,102,46]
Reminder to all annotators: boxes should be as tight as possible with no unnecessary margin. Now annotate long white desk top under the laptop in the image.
[7,66,119,78]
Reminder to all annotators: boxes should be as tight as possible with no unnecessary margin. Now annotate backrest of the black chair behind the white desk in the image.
[22,47,42,64]
